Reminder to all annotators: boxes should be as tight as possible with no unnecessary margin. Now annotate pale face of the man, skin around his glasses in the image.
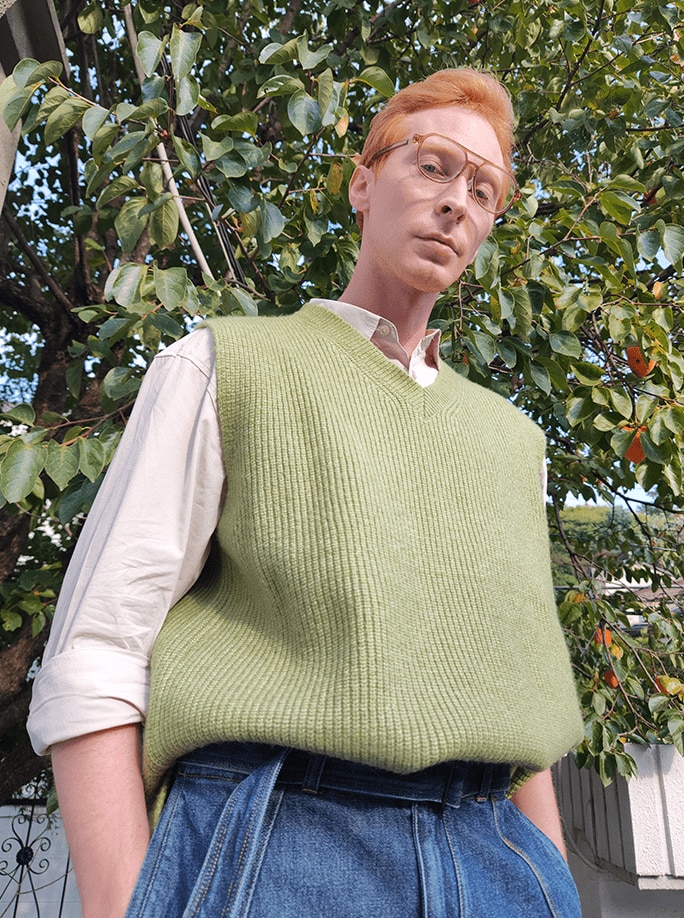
[351,105,505,293]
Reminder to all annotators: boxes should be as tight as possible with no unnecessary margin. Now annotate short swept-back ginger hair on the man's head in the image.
[356,67,515,229]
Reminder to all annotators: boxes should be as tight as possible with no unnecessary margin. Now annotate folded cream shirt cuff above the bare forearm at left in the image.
[26,645,149,755]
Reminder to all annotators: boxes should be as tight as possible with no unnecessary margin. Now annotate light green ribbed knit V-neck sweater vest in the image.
[145,303,582,790]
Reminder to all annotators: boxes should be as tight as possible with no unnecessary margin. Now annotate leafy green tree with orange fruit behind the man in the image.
[0,0,684,797]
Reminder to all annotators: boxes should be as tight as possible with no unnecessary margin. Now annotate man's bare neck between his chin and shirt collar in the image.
[339,267,437,354]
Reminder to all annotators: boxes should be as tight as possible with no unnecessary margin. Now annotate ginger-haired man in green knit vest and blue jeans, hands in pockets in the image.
[30,69,581,918]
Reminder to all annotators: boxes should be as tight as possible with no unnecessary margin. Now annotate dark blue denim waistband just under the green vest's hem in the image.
[179,742,511,807]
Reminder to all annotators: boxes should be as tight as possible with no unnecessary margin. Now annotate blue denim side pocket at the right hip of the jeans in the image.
[493,799,581,918]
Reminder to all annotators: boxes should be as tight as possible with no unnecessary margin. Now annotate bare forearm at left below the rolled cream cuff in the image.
[52,724,150,918]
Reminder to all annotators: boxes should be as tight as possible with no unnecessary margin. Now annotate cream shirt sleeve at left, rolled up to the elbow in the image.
[28,329,225,754]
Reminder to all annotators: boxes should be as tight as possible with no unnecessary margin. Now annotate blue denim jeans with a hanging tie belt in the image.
[127,743,580,918]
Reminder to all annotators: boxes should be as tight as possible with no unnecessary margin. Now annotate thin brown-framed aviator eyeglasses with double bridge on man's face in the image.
[366,134,520,217]
